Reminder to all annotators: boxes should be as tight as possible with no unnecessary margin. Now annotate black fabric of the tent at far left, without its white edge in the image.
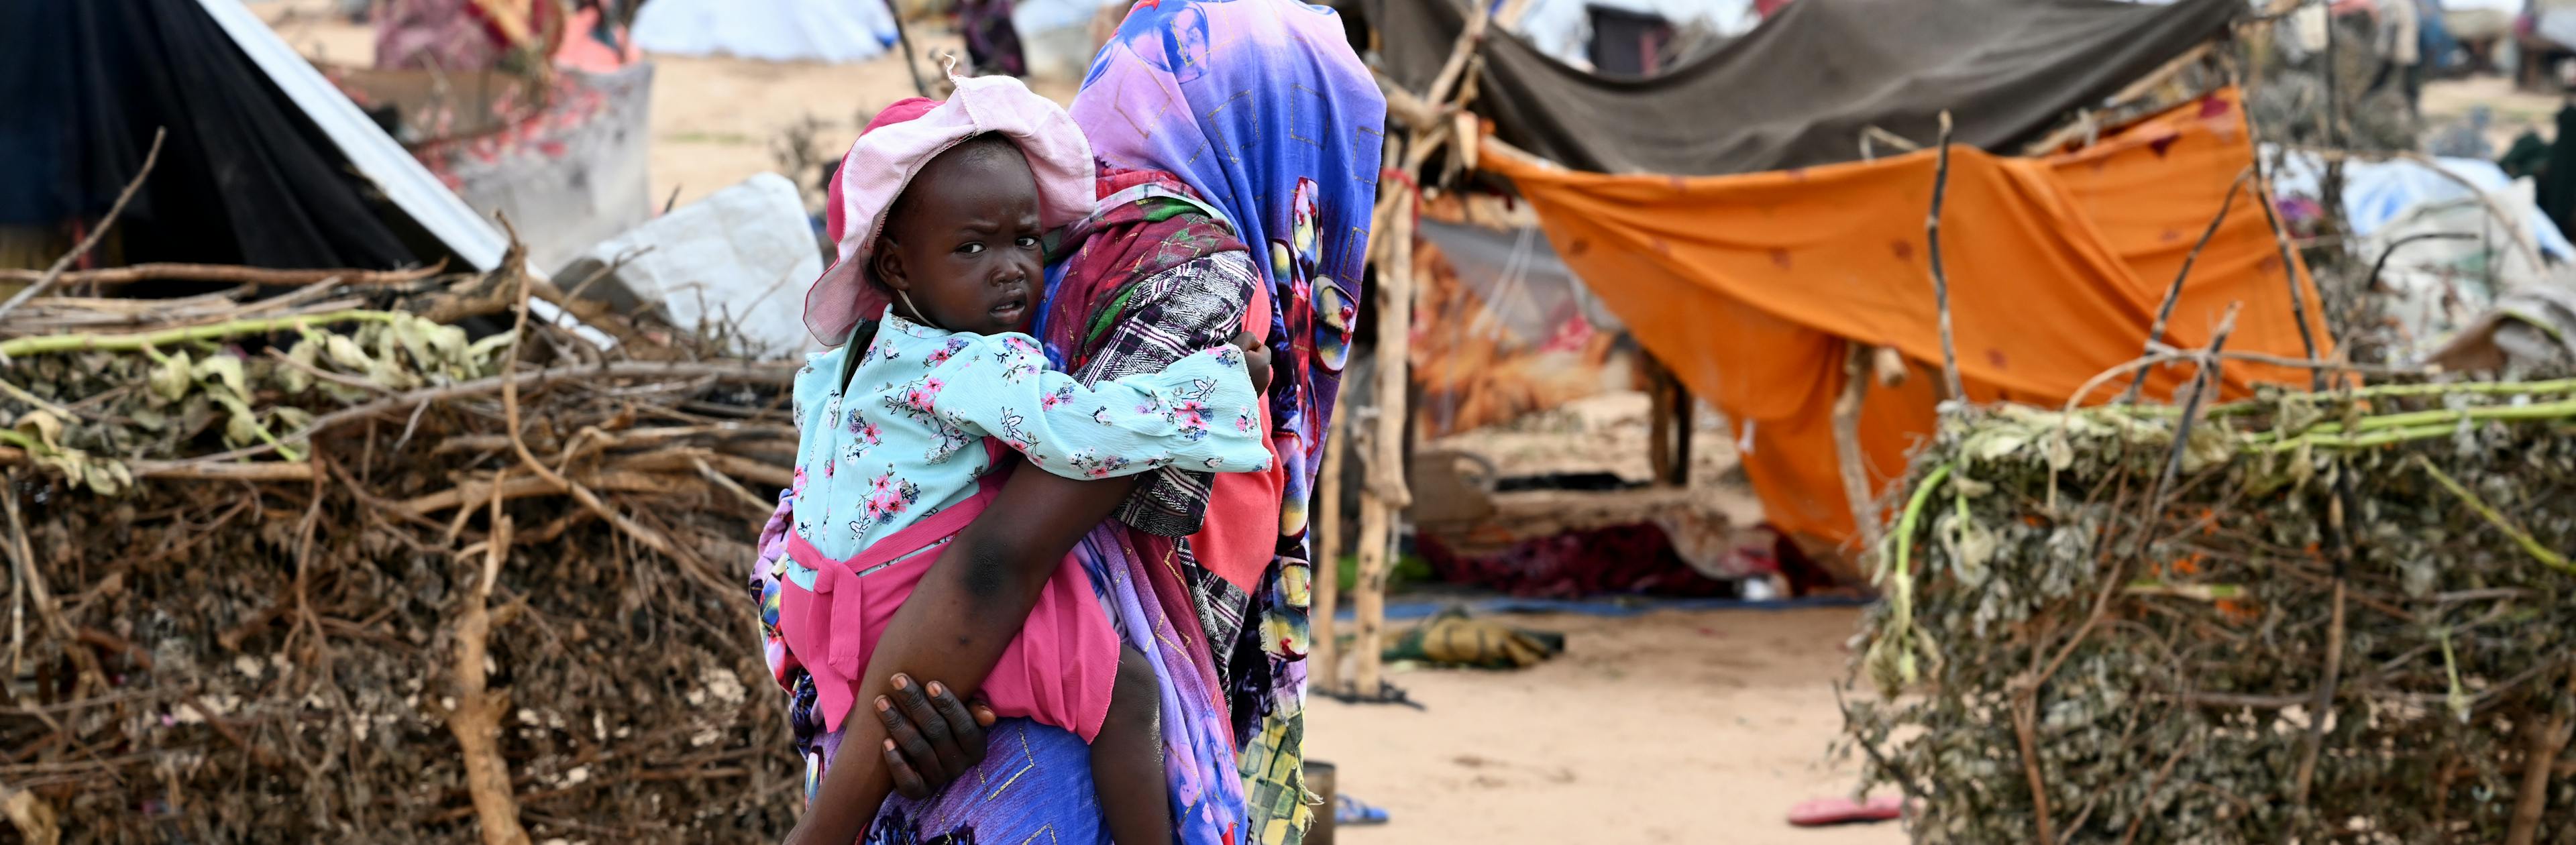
[0,0,438,268]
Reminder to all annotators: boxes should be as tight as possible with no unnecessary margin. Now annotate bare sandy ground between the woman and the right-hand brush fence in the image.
[1306,608,1907,845]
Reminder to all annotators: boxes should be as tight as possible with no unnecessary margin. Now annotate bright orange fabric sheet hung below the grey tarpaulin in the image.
[1481,90,2328,544]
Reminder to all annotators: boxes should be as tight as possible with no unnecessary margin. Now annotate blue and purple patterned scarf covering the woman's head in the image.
[1071,0,1386,533]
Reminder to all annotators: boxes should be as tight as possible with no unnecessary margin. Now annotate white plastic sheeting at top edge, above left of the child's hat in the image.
[634,0,894,64]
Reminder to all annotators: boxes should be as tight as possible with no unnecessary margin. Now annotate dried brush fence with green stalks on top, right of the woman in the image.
[1844,382,2576,845]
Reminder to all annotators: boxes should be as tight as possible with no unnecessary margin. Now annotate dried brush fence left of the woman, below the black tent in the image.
[0,247,798,845]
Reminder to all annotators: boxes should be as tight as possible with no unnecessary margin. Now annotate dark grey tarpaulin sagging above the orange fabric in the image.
[1368,0,2244,175]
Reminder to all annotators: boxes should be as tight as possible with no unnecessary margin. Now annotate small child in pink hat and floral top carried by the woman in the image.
[763,80,1270,845]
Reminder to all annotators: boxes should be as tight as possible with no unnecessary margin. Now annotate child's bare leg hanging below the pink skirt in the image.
[1092,646,1172,845]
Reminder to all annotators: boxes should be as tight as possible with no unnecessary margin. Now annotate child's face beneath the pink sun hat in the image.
[876,142,1043,335]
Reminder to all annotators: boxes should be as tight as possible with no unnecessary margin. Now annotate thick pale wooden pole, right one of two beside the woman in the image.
[1350,188,1417,698]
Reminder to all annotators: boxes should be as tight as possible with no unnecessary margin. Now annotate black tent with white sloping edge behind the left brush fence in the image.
[0,0,597,345]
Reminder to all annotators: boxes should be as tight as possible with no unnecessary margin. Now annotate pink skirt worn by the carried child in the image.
[778,441,1118,742]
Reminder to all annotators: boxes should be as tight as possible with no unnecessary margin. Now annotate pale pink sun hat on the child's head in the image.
[806,77,1097,345]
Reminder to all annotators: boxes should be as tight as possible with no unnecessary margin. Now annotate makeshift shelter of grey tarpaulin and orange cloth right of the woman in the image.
[1339,0,2326,561]
